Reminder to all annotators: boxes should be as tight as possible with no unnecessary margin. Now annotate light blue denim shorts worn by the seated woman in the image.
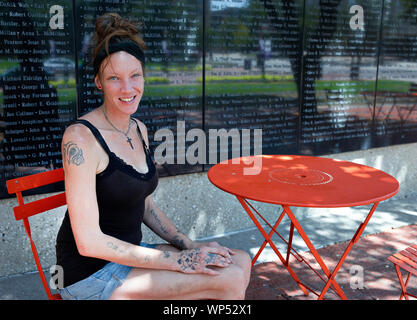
[59,242,157,300]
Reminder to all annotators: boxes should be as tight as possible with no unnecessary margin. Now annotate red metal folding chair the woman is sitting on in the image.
[6,168,67,300]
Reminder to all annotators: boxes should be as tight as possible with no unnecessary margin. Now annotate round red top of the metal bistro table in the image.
[208,155,399,208]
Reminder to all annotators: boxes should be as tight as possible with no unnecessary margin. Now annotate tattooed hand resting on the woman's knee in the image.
[177,246,233,275]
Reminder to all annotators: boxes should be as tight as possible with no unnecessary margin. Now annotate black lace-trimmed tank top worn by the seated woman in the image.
[56,119,158,287]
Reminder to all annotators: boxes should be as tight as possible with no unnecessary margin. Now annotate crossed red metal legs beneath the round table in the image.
[236,196,379,300]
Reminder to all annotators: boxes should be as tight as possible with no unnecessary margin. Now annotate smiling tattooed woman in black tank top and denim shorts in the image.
[56,14,250,299]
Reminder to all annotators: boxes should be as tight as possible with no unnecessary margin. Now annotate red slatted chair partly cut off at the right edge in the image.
[388,245,417,300]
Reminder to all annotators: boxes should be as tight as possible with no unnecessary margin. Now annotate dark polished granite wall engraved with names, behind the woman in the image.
[0,0,417,198]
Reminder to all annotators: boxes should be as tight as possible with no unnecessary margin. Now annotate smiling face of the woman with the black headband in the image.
[94,51,144,115]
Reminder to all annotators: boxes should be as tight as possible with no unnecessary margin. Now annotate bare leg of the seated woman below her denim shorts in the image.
[110,245,251,300]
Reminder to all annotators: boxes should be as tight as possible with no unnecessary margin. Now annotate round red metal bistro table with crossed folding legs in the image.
[208,155,399,300]
